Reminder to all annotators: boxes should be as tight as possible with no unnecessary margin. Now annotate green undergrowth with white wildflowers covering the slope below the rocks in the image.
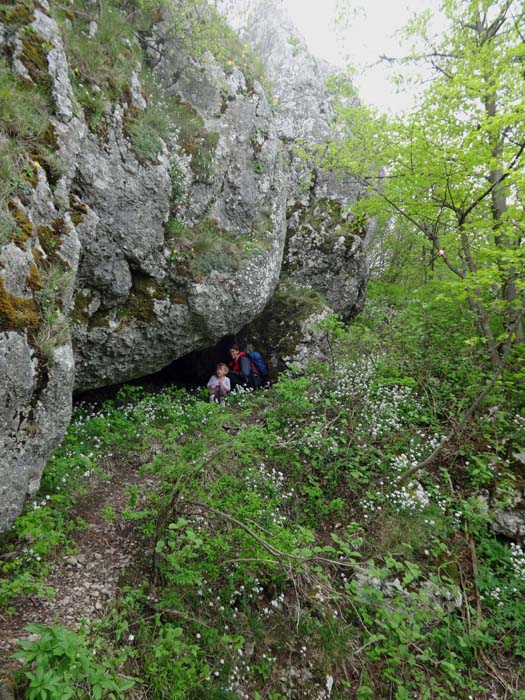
[0,287,525,700]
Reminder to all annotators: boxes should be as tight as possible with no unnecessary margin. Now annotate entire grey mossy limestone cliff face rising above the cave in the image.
[0,0,367,531]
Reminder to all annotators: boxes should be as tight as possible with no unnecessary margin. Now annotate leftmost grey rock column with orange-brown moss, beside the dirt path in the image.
[0,2,80,531]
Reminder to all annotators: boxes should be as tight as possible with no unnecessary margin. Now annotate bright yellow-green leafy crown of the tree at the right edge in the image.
[327,0,525,367]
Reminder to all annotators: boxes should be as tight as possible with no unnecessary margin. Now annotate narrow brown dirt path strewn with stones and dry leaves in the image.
[0,454,155,675]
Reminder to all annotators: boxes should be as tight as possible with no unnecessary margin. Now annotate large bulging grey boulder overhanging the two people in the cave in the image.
[70,30,287,390]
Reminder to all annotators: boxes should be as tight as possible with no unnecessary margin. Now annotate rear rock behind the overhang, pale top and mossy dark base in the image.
[237,2,370,360]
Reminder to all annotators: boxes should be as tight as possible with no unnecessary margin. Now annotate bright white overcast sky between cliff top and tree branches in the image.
[283,0,439,112]
